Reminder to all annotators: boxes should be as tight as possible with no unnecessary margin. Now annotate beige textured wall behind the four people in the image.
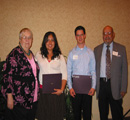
[0,0,130,120]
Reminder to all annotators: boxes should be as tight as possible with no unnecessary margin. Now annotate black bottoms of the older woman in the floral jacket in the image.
[5,102,37,120]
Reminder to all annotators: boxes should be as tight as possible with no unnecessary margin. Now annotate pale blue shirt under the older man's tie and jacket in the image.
[100,42,113,77]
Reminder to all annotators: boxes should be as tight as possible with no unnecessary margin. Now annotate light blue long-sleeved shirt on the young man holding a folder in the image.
[67,46,96,89]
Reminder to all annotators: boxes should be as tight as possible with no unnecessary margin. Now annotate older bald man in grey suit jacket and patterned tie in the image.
[94,26,128,120]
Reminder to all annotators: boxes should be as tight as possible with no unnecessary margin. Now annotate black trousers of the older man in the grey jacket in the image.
[98,79,123,120]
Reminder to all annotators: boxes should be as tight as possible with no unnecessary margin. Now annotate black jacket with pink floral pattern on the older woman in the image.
[2,46,39,109]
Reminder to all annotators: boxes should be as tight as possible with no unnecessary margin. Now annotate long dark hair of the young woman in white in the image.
[40,31,61,60]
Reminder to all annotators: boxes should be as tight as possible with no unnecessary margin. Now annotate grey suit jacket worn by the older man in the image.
[94,42,128,100]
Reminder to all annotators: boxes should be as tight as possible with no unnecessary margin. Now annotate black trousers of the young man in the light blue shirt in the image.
[72,94,92,120]
